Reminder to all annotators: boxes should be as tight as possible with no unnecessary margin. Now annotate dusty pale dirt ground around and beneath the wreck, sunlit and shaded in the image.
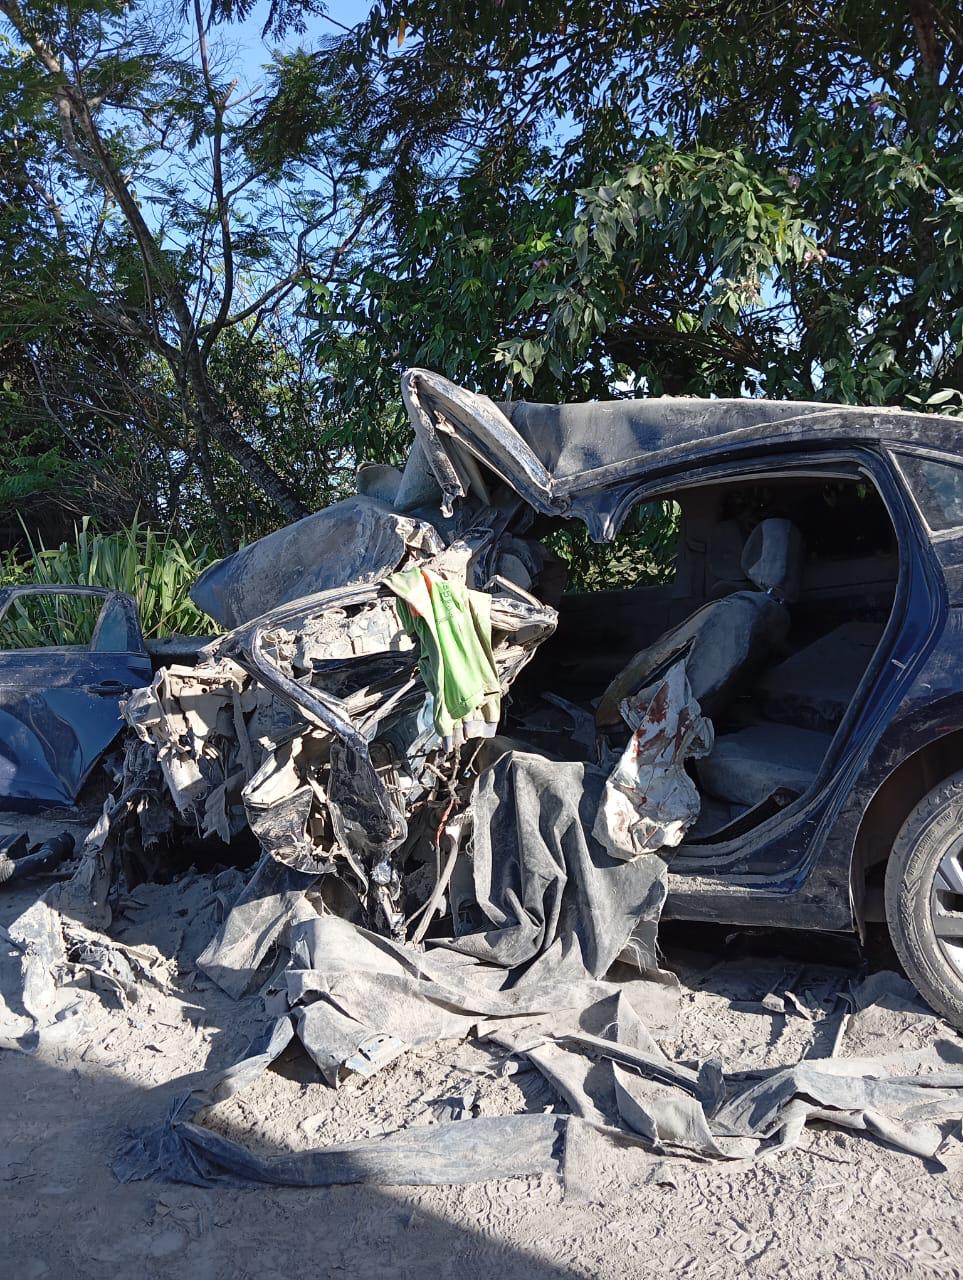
[0,824,963,1280]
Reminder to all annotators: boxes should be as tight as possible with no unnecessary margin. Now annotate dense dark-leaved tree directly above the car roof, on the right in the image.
[259,0,963,430]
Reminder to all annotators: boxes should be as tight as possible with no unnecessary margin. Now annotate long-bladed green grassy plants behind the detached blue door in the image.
[0,517,211,648]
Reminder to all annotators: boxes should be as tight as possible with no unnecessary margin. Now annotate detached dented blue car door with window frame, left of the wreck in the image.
[0,586,151,812]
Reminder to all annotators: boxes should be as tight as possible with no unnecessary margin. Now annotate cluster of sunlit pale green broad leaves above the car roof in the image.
[497,141,818,385]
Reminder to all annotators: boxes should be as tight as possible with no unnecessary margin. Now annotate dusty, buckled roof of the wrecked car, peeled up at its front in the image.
[402,369,963,536]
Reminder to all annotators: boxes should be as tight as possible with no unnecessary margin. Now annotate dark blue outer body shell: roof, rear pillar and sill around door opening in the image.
[403,370,963,929]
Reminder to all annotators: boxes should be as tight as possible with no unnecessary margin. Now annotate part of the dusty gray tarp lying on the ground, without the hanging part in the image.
[115,916,963,1185]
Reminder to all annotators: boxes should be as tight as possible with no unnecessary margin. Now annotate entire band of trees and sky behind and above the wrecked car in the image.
[0,0,963,576]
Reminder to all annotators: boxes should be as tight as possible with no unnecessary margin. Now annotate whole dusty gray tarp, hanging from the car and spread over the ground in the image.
[115,753,963,1185]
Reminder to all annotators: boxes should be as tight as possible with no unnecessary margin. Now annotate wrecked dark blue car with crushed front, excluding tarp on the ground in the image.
[86,370,963,1025]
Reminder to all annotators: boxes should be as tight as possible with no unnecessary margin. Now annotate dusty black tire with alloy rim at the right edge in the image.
[885,772,963,1028]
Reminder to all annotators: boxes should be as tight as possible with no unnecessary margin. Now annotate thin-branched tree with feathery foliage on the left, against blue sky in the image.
[0,0,379,549]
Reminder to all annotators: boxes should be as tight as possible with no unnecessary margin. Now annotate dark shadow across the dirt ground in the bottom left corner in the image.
[0,1053,587,1280]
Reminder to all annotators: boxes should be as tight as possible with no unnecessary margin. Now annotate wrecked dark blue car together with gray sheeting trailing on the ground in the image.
[13,370,963,1190]
